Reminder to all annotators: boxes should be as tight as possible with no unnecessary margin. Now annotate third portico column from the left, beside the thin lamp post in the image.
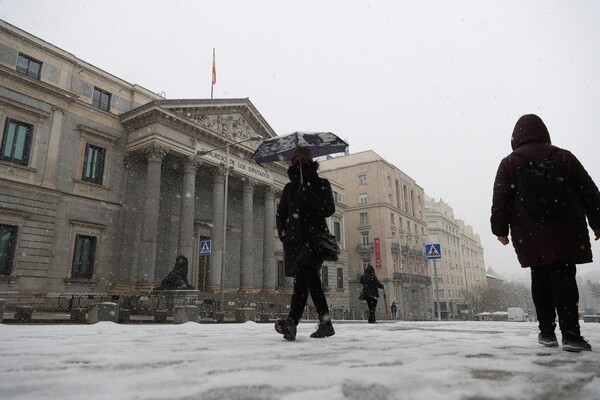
[206,169,225,292]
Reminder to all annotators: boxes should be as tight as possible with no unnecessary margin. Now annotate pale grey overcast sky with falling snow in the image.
[0,0,600,277]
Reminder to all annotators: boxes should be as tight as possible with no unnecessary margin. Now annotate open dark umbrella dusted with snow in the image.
[251,132,348,182]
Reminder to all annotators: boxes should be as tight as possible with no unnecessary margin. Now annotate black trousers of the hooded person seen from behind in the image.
[531,263,580,335]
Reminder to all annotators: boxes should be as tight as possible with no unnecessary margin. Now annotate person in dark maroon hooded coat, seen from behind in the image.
[490,114,600,351]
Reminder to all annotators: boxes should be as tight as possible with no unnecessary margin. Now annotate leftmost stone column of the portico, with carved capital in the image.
[138,144,167,289]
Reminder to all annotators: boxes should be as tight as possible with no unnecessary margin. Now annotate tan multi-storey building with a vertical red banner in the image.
[320,151,433,320]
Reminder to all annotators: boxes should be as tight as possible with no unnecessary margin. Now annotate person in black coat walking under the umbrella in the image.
[275,148,335,340]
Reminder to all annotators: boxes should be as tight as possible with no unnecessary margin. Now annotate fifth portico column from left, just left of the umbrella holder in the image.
[263,186,277,293]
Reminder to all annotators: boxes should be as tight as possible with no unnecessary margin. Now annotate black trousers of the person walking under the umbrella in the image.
[289,254,329,325]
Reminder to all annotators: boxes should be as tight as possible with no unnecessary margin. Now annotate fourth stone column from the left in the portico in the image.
[240,179,256,293]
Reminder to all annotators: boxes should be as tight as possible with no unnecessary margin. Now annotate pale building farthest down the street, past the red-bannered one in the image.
[425,197,487,320]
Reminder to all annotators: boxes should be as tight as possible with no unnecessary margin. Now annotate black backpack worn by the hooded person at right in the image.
[511,149,571,220]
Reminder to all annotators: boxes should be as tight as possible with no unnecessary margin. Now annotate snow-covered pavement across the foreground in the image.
[0,322,600,400]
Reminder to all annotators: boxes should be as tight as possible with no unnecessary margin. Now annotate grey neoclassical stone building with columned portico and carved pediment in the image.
[0,21,348,310]
